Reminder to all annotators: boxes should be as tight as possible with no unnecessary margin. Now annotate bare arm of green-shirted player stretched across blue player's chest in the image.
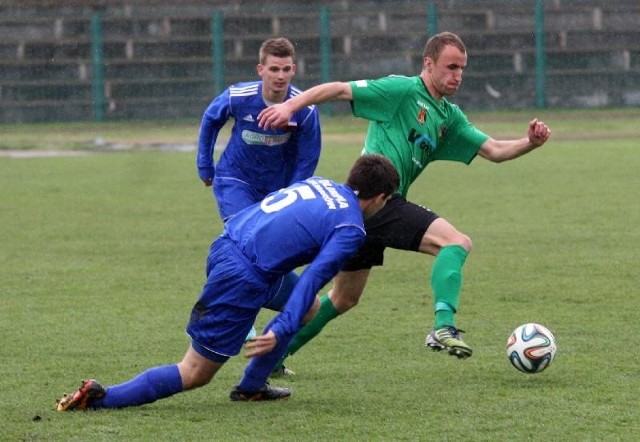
[258,82,353,130]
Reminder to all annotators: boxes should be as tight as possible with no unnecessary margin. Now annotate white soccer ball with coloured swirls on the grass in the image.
[507,323,558,373]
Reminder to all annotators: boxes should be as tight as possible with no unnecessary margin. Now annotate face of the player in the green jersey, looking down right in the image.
[424,45,467,99]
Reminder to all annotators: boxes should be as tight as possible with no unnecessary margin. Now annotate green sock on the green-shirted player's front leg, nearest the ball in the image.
[431,245,467,329]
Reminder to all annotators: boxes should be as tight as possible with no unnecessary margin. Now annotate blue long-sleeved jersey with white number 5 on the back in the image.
[222,177,366,340]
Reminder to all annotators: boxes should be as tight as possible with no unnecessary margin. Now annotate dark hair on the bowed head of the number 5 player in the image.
[346,154,400,200]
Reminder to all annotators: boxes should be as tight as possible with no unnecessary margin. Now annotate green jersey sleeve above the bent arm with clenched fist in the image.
[436,105,489,164]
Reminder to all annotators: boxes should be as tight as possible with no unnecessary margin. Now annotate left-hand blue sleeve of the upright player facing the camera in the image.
[196,89,232,180]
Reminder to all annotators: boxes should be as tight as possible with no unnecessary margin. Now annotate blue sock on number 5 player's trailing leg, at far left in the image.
[90,364,182,408]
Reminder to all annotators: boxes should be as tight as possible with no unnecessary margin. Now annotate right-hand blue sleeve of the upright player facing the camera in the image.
[288,106,322,185]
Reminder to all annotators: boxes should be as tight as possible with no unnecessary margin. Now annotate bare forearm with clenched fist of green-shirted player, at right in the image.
[478,118,551,163]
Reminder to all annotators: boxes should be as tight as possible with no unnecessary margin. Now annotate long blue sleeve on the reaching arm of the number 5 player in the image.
[271,225,365,341]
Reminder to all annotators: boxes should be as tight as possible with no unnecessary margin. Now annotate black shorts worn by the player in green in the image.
[342,195,439,272]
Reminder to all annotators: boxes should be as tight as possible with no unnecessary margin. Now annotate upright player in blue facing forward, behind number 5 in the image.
[196,38,321,220]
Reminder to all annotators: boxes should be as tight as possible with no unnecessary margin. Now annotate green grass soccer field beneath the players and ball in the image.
[0,109,640,441]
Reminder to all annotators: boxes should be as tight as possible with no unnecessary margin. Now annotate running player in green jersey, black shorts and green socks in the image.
[258,32,551,368]
